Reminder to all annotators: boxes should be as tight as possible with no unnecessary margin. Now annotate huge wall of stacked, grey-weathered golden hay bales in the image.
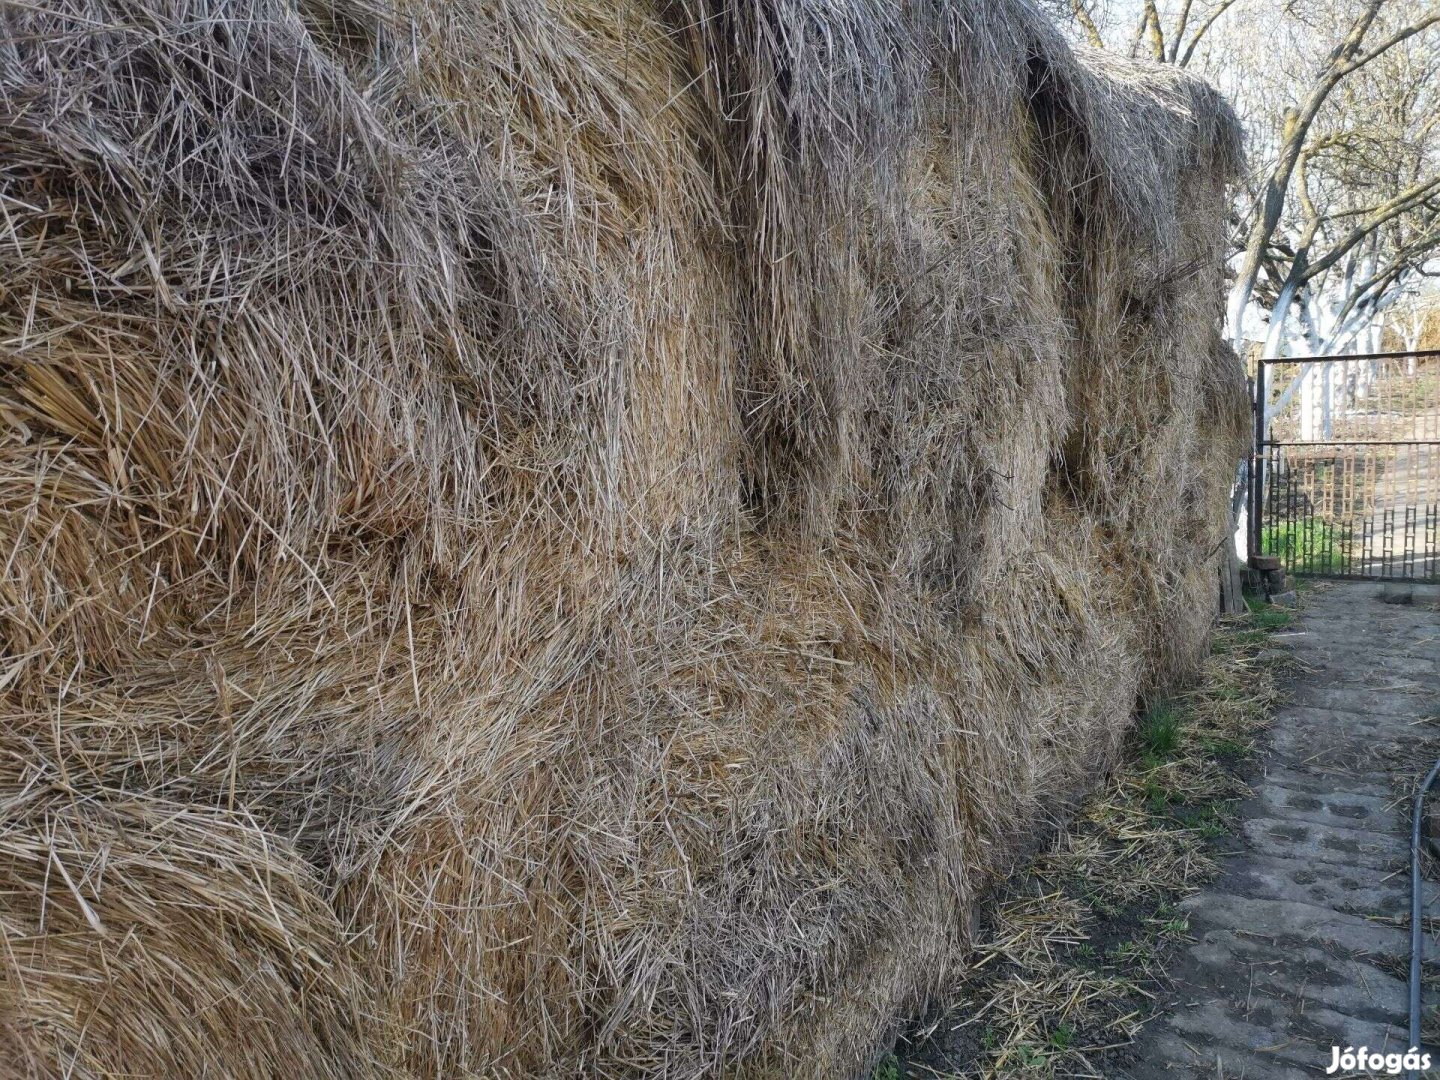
[0,0,1243,1080]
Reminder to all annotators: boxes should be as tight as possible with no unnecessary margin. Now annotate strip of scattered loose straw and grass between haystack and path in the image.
[877,609,1290,1080]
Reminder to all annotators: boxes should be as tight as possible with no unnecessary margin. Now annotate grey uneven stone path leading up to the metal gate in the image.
[1120,583,1440,1080]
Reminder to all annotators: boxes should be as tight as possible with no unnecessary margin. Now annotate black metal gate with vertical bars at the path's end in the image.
[1248,350,1440,580]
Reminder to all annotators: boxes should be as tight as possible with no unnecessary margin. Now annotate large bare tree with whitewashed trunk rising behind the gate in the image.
[1227,0,1440,356]
